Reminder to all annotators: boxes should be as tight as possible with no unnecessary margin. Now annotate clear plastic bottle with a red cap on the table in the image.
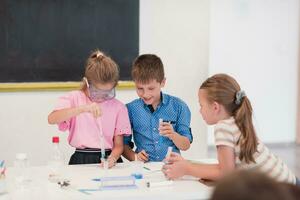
[48,136,64,182]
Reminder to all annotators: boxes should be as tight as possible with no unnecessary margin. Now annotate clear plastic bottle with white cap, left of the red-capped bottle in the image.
[14,153,29,188]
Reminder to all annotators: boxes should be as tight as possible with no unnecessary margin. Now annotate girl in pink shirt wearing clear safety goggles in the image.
[48,50,131,167]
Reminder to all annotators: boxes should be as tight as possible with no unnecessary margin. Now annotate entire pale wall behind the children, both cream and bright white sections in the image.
[0,0,299,165]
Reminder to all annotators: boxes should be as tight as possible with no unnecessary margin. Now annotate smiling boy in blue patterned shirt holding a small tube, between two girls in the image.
[123,54,193,162]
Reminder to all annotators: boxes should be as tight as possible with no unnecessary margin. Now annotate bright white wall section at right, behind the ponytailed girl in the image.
[208,0,300,144]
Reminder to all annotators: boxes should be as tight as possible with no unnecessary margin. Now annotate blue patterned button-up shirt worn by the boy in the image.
[124,93,193,161]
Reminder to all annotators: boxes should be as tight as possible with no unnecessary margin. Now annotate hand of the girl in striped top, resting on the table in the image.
[162,159,189,179]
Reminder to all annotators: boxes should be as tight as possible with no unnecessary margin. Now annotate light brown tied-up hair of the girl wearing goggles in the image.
[81,49,119,90]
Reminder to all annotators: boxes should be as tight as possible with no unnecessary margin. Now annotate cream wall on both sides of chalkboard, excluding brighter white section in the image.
[0,0,209,165]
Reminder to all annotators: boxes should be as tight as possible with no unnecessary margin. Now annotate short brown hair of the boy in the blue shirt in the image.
[131,54,165,83]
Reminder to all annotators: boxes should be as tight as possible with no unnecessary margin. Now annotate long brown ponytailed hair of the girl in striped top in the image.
[200,74,258,163]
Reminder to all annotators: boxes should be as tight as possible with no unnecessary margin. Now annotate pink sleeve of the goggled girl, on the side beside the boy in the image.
[115,105,131,135]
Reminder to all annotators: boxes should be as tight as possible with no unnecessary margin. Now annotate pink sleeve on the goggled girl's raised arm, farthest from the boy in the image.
[54,93,73,131]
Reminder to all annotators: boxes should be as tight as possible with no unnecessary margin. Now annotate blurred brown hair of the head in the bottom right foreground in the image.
[211,170,299,200]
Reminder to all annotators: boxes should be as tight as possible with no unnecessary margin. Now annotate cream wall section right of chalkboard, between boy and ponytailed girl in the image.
[140,0,209,158]
